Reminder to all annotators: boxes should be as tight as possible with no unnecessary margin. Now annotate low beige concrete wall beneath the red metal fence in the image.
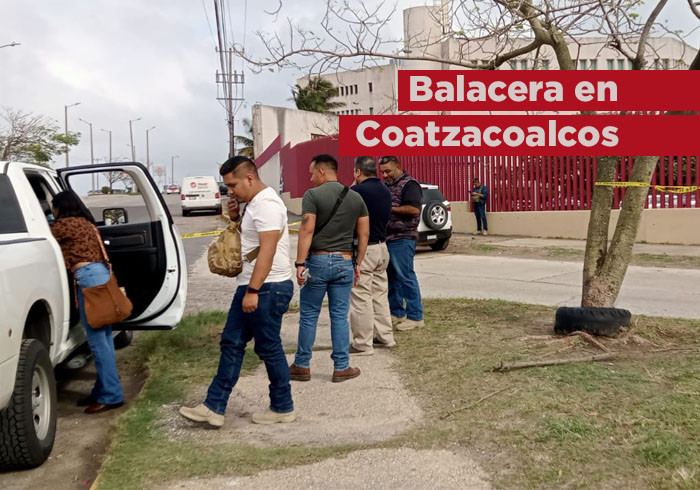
[282,192,700,245]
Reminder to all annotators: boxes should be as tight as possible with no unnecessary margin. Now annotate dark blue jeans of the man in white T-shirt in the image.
[204,281,294,415]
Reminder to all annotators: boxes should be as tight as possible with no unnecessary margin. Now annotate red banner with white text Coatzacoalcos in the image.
[339,115,700,156]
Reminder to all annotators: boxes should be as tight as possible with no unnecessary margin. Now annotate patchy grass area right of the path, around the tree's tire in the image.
[397,300,700,489]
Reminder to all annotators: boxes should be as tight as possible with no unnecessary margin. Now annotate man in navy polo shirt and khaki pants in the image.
[350,156,396,356]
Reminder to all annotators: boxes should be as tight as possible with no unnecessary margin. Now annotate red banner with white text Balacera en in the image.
[398,70,700,111]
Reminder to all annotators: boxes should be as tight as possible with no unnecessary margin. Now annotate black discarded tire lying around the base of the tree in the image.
[554,307,632,337]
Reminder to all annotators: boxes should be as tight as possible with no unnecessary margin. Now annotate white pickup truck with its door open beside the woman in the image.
[0,162,187,471]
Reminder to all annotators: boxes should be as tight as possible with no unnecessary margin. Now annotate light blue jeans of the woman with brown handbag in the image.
[74,262,124,405]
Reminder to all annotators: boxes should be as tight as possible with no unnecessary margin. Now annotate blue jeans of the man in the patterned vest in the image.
[386,238,423,320]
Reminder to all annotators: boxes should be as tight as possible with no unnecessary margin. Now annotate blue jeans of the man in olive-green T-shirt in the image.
[294,254,355,371]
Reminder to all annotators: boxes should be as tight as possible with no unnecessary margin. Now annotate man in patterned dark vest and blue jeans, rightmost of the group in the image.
[379,156,424,330]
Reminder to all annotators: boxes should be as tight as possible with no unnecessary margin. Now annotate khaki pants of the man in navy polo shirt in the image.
[350,243,394,351]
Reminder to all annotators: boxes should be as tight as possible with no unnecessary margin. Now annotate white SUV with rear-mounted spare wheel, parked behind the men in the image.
[418,184,452,250]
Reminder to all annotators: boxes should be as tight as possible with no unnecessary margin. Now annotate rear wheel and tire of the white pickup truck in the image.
[0,339,56,471]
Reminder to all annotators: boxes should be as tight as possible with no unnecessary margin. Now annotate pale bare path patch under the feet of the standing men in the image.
[162,351,423,447]
